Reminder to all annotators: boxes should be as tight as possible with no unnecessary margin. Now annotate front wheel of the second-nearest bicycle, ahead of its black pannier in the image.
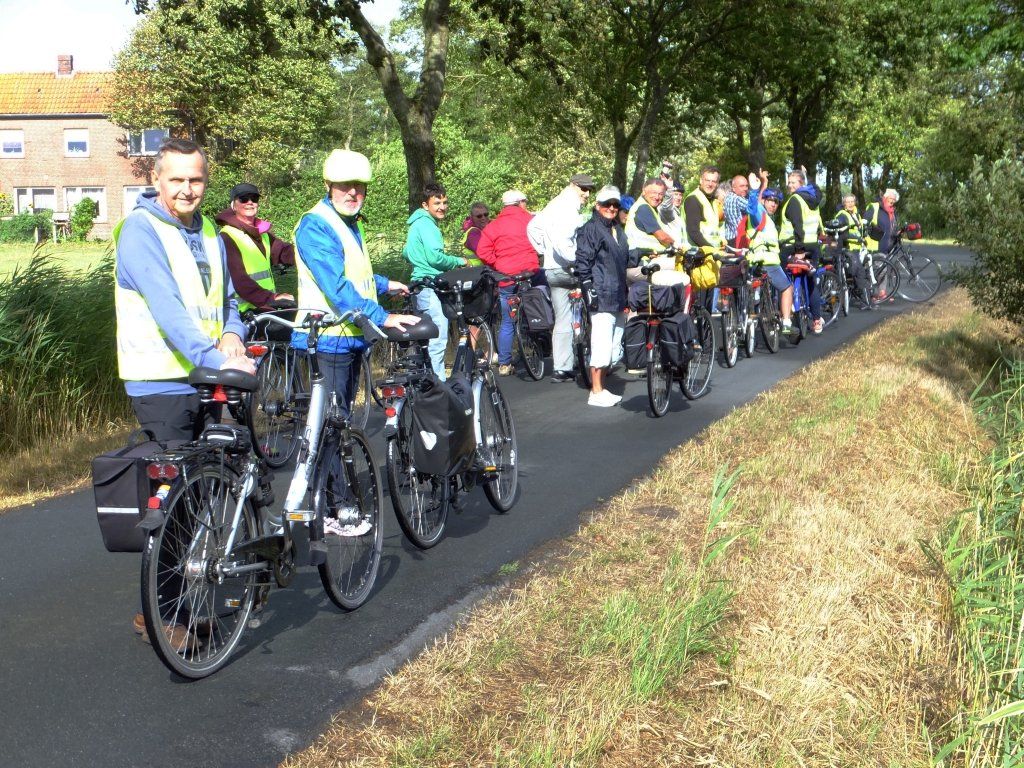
[474,375,519,512]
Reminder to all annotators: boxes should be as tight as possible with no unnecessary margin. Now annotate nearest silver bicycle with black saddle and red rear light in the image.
[140,312,385,679]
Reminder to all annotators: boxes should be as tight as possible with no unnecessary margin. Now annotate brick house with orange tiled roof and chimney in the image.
[0,55,168,238]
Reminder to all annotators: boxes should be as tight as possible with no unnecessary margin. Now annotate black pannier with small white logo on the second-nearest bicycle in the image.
[412,376,476,476]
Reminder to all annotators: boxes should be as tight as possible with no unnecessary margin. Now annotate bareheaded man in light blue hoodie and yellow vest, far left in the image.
[114,138,255,647]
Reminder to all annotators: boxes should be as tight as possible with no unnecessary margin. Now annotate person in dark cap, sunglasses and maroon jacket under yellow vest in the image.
[216,183,295,312]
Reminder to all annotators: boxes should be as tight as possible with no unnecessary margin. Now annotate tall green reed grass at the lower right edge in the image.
[930,360,1024,767]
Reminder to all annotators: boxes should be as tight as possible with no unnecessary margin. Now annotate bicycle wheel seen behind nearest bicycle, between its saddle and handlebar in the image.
[246,345,302,469]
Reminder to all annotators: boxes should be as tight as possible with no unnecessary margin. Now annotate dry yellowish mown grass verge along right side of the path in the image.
[284,292,1010,768]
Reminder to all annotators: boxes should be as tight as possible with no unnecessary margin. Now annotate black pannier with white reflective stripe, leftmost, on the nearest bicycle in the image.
[92,430,167,552]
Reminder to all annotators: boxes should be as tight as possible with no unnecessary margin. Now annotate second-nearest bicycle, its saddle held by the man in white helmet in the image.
[380,278,519,549]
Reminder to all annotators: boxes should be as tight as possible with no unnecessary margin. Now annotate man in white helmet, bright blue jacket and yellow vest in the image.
[292,150,420,415]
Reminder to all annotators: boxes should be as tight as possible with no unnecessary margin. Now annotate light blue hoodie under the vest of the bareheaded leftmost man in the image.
[115,191,246,397]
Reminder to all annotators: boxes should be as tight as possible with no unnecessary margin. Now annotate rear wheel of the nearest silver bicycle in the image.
[141,458,259,680]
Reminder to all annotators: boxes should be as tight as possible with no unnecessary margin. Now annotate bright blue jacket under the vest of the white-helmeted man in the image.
[292,195,388,354]
